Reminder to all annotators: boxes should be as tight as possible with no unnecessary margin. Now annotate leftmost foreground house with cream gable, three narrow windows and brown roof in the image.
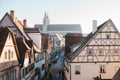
[0,27,20,80]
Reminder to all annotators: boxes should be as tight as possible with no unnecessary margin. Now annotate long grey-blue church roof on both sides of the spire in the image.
[35,24,82,32]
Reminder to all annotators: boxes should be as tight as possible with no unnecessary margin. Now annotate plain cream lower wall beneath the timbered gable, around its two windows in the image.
[71,63,120,80]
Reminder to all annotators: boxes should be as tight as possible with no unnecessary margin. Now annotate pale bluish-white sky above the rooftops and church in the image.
[0,0,120,33]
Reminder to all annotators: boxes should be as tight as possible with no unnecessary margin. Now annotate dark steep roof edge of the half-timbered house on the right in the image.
[67,19,118,62]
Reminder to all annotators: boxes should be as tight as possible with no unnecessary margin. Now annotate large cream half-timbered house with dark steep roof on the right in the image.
[64,19,120,80]
